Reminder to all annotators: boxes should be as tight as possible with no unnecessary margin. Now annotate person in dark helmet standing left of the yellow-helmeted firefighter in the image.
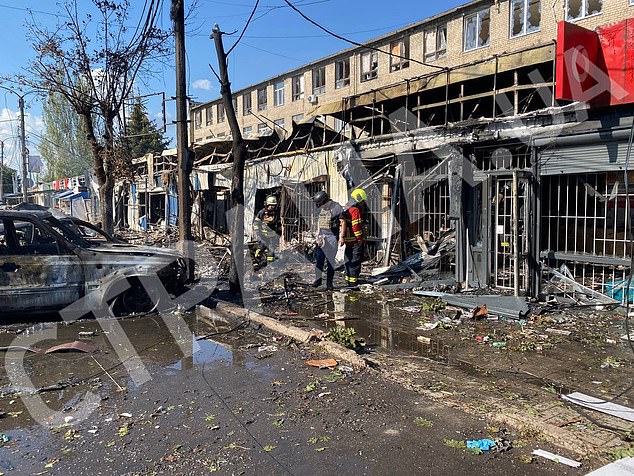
[313,191,343,291]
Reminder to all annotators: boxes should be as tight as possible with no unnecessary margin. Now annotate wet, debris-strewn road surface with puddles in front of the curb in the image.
[0,306,582,475]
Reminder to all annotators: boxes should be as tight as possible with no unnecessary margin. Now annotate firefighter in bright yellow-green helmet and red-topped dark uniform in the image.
[339,188,368,286]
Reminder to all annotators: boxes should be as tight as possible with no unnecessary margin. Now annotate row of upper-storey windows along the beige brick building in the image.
[195,0,608,128]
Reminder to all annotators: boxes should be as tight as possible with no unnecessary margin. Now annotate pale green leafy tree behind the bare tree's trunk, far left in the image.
[40,89,93,180]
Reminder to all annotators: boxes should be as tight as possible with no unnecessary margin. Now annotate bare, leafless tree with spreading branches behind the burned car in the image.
[23,0,169,232]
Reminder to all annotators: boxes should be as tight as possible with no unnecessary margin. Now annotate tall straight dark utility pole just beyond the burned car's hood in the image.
[170,0,194,279]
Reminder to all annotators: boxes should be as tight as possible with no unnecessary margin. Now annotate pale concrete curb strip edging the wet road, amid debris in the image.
[216,304,366,370]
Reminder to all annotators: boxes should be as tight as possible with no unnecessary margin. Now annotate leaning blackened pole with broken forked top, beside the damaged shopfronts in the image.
[212,24,247,293]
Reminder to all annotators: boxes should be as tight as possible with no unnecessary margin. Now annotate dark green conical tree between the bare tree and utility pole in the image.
[123,100,169,159]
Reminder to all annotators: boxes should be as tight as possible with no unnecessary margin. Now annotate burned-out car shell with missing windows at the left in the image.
[0,210,188,317]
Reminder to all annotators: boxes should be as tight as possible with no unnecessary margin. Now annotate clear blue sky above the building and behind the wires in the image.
[0,0,466,171]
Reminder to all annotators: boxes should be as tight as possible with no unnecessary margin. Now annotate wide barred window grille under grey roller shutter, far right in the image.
[541,172,634,300]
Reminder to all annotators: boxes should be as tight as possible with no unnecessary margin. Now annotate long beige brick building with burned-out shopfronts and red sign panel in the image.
[175,0,634,298]
